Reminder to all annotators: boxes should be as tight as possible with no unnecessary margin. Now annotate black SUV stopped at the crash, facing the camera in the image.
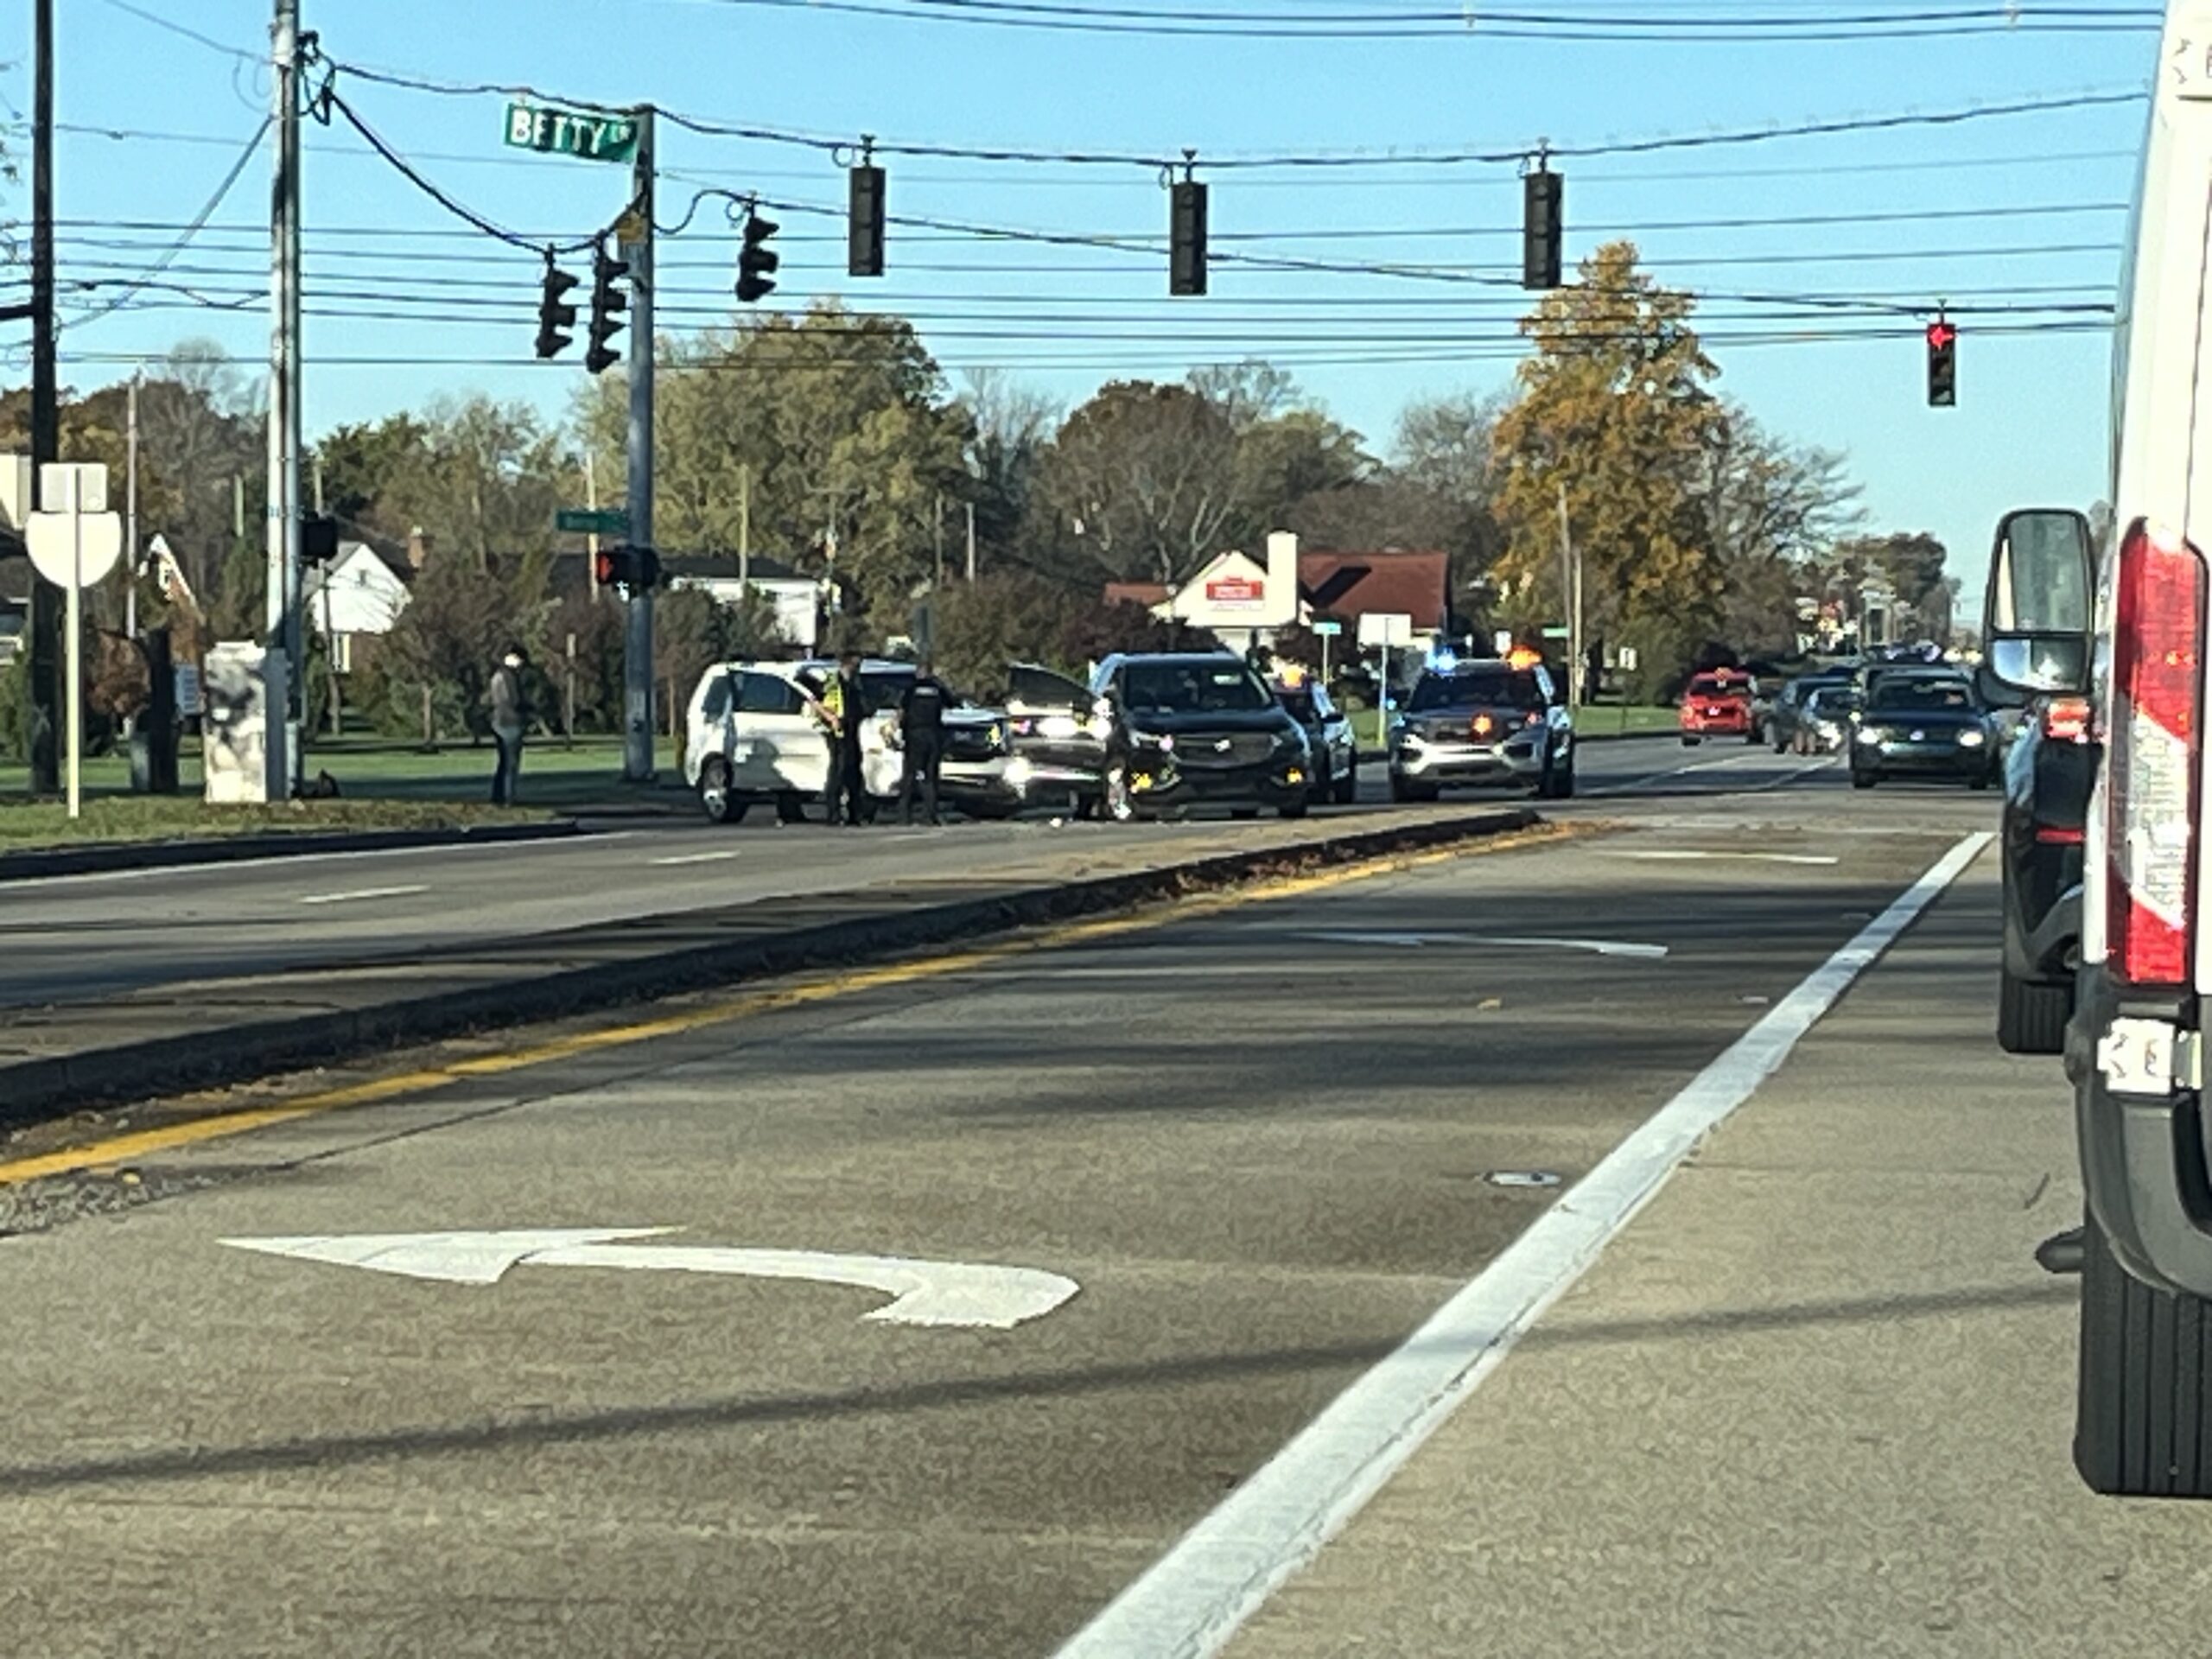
[1090,652,1312,821]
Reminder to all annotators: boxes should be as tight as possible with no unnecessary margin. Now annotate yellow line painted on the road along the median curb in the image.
[0,825,1573,1188]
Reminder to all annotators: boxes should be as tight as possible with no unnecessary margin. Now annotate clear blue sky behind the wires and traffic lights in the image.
[21,0,2154,597]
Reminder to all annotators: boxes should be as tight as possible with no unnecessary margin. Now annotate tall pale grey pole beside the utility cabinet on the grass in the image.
[264,0,301,801]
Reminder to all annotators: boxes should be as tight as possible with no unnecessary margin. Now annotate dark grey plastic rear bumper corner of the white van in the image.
[2066,967,2212,1299]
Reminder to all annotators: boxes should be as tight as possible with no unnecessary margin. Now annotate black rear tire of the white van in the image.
[2075,1217,2212,1497]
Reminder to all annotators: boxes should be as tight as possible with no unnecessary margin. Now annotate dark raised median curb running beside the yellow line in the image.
[0,810,1541,1130]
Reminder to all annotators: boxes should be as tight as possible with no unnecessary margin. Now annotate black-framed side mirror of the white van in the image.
[1978,506,2097,708]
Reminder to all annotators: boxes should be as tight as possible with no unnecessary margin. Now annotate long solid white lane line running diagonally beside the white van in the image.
[1058,832,1993,1659]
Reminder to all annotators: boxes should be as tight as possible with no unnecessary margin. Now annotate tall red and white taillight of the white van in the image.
[2106,520,2205,984]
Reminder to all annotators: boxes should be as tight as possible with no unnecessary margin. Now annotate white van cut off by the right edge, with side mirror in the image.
[1984,0,2212,1497]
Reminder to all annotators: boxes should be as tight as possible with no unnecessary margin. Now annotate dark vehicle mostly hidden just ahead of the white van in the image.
[1998,696,2097,1055]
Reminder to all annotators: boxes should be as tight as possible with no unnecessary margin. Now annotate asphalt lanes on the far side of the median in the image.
[0,741,1801,1008]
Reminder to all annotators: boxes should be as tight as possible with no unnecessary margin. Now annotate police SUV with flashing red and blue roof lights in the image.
[1389,659,1575,801]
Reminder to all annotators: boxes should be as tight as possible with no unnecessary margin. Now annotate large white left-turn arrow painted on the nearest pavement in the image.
[219,1228,1079,1332]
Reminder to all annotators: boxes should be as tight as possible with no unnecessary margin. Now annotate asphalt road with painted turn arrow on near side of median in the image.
[0,752,2123,1659]
